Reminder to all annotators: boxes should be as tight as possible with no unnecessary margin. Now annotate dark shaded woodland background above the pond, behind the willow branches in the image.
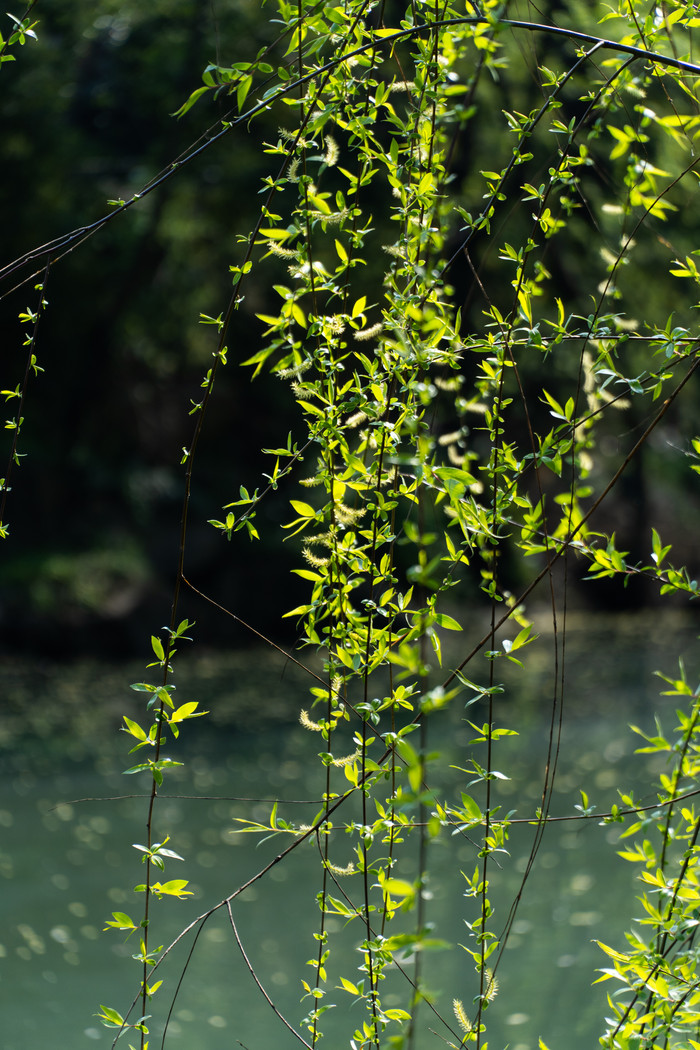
[0,0,700,655]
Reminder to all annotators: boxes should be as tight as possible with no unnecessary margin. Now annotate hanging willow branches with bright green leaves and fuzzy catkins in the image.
[3,0,700,1050]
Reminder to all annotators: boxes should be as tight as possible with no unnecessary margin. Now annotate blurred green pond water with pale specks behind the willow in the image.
[0,616,700,1050]
